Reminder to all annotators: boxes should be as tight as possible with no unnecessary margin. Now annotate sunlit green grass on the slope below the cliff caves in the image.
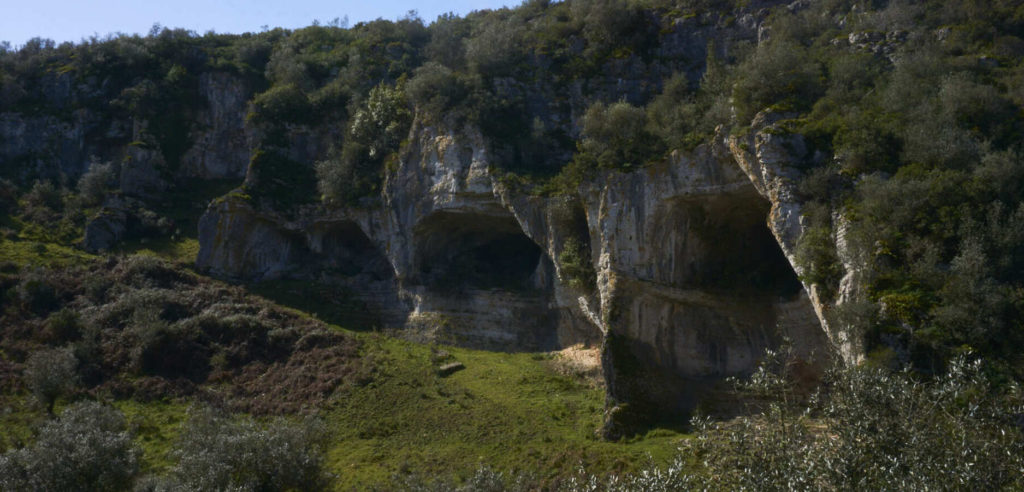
[0,228,685,490]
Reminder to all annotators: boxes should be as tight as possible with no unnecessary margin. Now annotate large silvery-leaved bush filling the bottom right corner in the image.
[561,354,1024,492]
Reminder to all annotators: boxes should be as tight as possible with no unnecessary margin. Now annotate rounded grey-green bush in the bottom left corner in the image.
[0,402,139,491]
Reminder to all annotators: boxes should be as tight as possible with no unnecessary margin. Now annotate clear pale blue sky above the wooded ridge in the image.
[0,0,512,46]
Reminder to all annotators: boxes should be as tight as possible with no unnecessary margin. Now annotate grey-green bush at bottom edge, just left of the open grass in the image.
[165,408,330,491]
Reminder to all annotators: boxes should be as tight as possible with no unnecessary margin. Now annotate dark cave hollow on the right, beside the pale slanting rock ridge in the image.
[674,195,803,298]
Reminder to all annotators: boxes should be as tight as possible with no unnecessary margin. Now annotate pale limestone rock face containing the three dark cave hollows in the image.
[198,118,837,436]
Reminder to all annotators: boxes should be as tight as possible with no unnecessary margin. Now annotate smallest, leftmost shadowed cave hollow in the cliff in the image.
[309,220,392,280]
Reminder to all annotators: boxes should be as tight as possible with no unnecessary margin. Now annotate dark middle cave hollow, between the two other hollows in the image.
[414,212,543,292]
